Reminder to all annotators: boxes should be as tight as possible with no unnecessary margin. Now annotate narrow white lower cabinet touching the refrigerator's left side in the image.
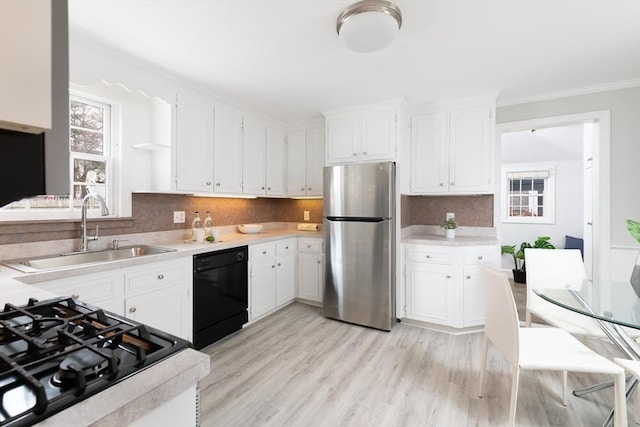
[298,238,324,304]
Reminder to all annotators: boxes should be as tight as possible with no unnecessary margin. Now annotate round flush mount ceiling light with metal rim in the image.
[337,0,402,52]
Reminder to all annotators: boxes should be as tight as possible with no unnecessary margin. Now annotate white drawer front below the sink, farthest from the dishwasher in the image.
[33,271,122,304]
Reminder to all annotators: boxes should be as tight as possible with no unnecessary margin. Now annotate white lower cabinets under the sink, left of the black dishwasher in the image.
[33,257,193,341]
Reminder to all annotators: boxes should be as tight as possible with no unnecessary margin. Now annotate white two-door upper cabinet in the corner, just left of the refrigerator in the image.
[287,128,324,197]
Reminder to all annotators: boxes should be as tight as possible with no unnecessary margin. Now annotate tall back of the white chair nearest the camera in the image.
[478,265,520,365]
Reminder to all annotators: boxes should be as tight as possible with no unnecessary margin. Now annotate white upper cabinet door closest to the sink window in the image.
[176,94,214,193]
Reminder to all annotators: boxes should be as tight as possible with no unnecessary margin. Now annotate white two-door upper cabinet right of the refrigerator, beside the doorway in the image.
[410,103,495,194]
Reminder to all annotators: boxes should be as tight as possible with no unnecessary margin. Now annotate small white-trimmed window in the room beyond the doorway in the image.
[502,165,555,224]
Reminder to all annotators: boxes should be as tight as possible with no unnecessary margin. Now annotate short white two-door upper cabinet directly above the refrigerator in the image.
[325,100,404,165]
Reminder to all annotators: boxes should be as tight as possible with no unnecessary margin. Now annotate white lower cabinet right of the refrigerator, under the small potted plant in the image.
[403,244,500,328]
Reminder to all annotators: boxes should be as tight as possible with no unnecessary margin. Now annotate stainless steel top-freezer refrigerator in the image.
[323,162,396,331]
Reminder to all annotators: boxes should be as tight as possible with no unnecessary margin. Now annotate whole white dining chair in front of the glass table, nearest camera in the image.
[478,265,627,426]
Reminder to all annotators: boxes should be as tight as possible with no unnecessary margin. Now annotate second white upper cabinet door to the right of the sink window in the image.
[213,108,242,194]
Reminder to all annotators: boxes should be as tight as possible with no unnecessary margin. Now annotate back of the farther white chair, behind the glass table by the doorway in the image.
[524,248,587,309]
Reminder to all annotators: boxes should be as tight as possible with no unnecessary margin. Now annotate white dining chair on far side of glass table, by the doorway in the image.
[524,248,640,339]
